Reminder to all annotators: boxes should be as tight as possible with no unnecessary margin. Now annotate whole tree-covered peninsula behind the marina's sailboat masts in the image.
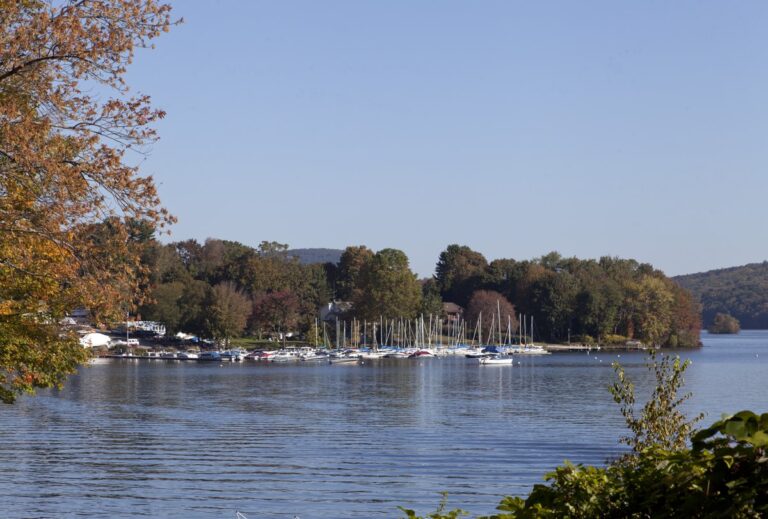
[138,237,701,347]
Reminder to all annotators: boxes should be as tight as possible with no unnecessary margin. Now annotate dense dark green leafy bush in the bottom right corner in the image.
[489,411,768,519]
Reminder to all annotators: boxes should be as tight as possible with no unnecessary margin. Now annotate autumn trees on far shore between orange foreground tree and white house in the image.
[141,239,331,338]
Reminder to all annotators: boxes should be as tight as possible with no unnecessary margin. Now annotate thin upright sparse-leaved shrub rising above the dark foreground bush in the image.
[609,350,703,453]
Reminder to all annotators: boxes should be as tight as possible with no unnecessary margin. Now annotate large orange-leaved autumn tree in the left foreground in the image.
[0,0,172,402]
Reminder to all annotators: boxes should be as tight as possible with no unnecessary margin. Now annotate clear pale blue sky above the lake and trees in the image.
[129,0,768,276]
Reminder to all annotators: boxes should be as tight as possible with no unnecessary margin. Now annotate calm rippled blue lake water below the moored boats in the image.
[0,331,768,519]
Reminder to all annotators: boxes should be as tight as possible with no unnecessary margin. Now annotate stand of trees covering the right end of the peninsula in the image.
[435,250,701,347]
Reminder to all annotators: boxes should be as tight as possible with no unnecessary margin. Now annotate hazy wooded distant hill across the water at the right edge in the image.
[672,261,768,329]
